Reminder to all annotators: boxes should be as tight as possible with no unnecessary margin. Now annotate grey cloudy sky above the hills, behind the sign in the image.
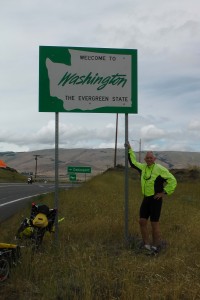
[0,0,200,152]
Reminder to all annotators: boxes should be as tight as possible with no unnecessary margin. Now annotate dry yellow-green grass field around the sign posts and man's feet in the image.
[0,171,200,300]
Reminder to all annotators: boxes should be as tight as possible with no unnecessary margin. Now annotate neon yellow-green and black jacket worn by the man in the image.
[128,149,177,196]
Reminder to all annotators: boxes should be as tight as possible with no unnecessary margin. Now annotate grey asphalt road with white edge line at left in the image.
[0,183,75,222]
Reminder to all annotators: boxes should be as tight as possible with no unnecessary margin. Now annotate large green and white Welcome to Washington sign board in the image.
[39,46,138,114]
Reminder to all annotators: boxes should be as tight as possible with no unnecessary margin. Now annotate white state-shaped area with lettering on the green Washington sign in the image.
[46,49,132,110]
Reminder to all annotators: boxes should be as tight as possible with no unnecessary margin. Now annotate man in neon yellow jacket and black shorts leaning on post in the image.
[128,143,177,253]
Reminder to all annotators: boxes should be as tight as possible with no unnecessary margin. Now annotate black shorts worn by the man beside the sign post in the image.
[140,196,162,222]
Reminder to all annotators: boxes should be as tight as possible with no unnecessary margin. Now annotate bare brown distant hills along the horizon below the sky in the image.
[0,148,200,176]
